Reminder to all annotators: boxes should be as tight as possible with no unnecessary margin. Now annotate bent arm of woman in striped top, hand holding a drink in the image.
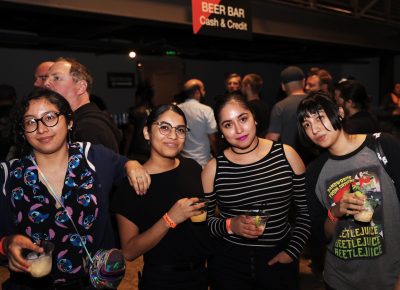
[201,159,263,239]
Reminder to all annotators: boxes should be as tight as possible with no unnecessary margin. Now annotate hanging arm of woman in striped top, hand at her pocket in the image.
[268,145,311,265]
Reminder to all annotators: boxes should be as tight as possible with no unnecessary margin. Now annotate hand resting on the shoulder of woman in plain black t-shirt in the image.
[125,160,151,195]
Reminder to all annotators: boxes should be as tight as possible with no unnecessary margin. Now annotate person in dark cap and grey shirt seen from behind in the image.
[265,66,306,156]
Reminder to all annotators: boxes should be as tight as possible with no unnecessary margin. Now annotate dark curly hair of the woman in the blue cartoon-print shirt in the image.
[13,89,72,157]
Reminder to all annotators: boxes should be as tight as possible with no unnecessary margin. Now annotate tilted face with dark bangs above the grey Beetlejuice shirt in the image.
[302,110,340,149]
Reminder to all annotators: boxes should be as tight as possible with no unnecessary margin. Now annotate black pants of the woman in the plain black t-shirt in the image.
[139,261,208,290]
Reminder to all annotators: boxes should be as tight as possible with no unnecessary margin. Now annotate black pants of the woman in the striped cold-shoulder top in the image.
[208,241,299,290]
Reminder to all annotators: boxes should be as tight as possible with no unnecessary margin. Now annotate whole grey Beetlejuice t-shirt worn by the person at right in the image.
[308,140,400,290]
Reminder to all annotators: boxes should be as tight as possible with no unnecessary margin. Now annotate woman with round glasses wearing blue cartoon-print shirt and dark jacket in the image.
[0,90,148,290]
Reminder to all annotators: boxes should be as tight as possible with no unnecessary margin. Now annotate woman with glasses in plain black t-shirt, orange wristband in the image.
[111,104,208,290]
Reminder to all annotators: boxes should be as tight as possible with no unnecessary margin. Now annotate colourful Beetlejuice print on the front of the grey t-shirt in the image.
[326,166,384,260]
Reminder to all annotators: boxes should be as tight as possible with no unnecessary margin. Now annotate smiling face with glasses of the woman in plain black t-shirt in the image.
[143,110,186,158]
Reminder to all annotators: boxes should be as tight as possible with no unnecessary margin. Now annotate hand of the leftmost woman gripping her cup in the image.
[4,235,43,272]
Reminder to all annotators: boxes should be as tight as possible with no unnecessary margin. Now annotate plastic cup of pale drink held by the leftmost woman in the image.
[25,241,54,278]
